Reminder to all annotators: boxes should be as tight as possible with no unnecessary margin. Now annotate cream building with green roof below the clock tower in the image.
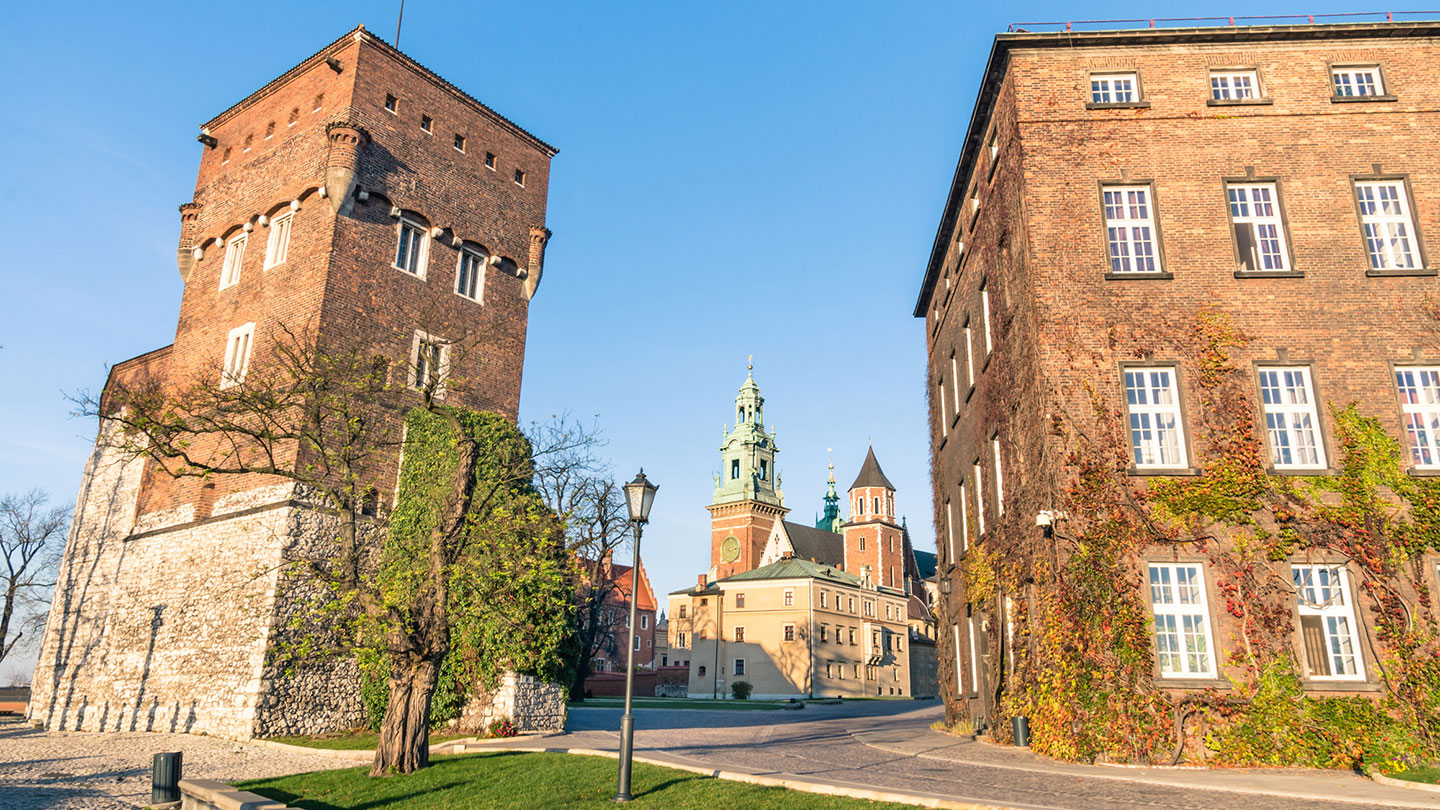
[670,558,913,699]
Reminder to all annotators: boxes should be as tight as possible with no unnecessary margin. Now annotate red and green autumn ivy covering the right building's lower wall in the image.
[952,308,1440,767]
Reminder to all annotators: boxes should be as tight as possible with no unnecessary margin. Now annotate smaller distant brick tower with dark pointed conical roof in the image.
[844,447,906,588]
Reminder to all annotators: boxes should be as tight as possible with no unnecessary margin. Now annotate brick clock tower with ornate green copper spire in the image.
[706,366,789,579]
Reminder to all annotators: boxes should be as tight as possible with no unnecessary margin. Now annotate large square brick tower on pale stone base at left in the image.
[29,27,556,739]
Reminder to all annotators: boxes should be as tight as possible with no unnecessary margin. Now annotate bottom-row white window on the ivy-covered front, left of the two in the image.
[1146,562,1217,677]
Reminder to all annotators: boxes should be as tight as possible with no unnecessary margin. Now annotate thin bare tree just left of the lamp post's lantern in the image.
[533,418,631,700]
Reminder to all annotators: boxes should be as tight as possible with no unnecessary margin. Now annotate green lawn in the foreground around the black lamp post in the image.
[236,754,910,810]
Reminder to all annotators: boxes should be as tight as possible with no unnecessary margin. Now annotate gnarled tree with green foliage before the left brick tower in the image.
[79,318,593,775]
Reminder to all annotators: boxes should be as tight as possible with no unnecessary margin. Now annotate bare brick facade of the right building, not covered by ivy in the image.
[914,23,1440,732]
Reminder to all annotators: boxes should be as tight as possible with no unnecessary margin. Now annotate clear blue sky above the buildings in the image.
[0,0,1393,668]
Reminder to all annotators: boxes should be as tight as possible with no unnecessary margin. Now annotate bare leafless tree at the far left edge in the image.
[0,490,71,663]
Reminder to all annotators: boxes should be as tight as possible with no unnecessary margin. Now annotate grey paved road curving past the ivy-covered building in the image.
[552,700,1440,810]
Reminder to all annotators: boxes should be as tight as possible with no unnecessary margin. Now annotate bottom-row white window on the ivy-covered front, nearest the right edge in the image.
[1292,565,1365,680]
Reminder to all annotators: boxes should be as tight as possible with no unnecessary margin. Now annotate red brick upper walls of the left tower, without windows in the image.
[117,29,554,517]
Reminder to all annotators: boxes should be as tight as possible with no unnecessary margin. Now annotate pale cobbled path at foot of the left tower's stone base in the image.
[0,721,356,810]
